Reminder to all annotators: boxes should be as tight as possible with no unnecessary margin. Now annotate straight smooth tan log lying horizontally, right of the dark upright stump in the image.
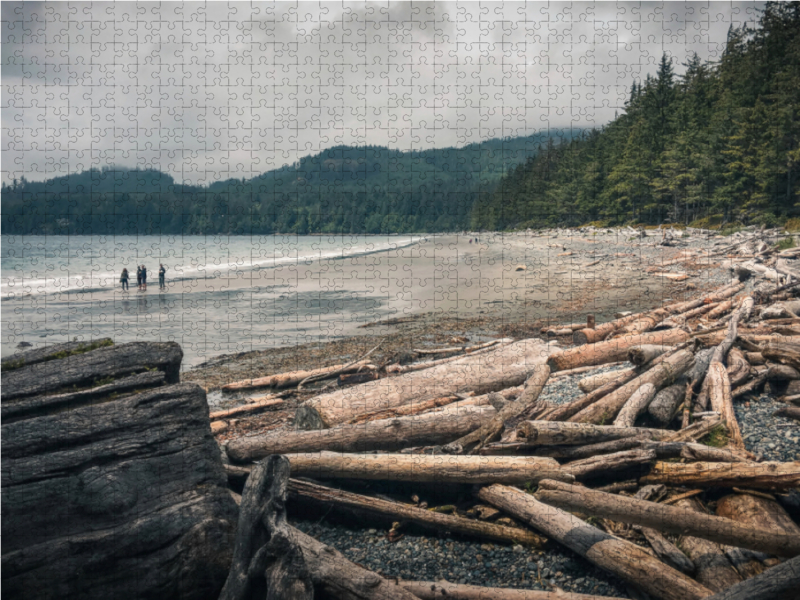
[286,452,574,484]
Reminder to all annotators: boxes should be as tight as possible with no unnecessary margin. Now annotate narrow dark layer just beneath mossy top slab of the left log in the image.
[0,371,166,423]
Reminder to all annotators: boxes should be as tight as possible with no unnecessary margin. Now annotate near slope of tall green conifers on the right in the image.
[472,2,800,229]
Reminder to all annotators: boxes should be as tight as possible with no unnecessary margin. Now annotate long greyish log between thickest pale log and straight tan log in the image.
[227,406,495,462]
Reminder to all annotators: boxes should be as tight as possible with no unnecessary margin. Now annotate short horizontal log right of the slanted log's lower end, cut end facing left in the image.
[517,421,666,446]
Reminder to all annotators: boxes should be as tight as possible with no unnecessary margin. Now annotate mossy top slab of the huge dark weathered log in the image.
[3,342,183,401]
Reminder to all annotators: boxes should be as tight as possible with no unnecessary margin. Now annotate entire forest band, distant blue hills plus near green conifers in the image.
[2,2,800,234]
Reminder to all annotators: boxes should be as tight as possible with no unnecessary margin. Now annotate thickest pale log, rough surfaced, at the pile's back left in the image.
[295,340,551,429]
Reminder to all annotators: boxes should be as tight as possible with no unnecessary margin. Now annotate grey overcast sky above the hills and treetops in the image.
[2,2,762,184]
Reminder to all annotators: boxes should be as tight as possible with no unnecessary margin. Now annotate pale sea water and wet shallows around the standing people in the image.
[0,235,424,367]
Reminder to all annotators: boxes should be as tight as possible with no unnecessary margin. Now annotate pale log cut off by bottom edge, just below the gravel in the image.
[399,581,620,600]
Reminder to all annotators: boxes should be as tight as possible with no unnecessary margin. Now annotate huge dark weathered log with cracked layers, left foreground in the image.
[1,342,238,600]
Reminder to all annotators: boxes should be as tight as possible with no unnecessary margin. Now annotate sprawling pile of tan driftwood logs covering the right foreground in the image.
[222,233,800,600]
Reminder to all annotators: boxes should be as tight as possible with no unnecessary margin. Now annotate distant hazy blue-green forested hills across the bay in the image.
[2,130,572,234]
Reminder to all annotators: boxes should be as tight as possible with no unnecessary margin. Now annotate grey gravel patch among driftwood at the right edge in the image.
[733,394,800,462]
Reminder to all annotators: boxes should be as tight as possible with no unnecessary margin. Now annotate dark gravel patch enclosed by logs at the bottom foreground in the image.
[292,520,629,598]
